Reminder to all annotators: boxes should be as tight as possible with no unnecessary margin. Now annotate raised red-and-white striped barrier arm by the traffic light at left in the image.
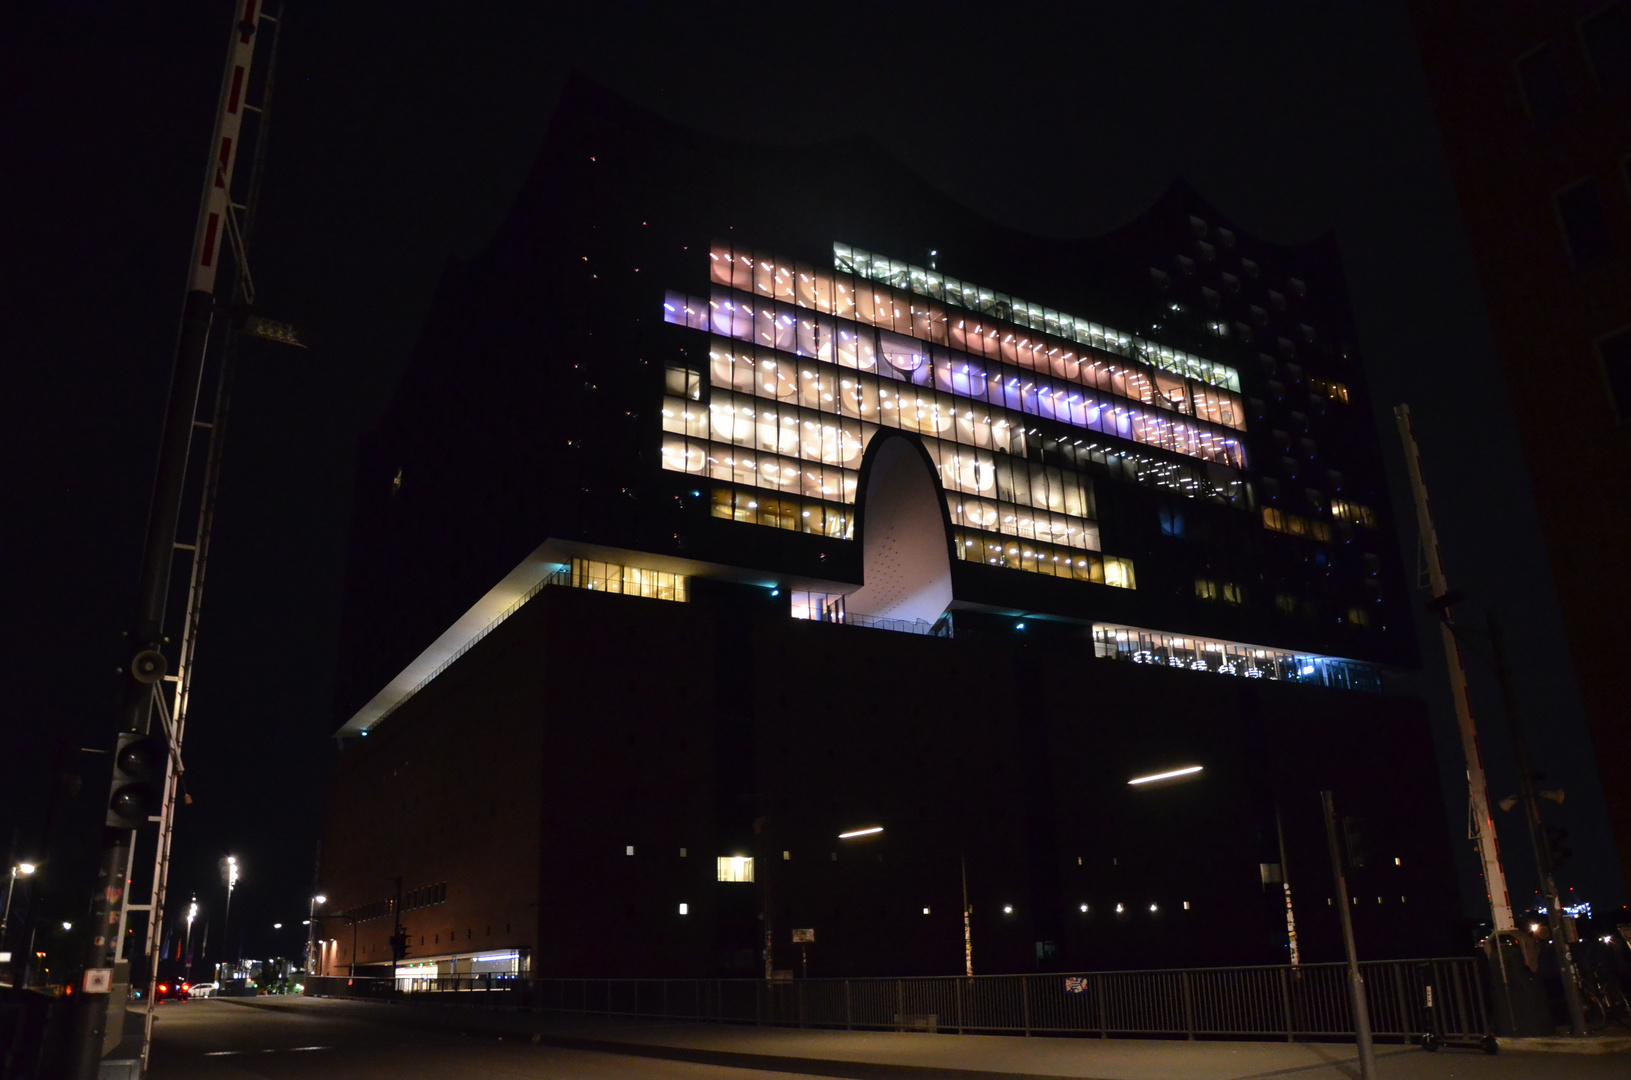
[69,8,259,1080]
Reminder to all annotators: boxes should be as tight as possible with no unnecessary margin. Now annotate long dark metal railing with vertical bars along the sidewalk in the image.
[307,958,1491,1041]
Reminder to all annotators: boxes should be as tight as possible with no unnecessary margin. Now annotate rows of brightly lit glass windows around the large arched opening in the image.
[661,226,1402,688]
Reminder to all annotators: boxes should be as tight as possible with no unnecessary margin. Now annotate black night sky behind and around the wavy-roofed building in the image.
[9,0,1624,972]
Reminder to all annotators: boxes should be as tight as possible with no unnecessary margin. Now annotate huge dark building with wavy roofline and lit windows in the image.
[311,82,1456,976]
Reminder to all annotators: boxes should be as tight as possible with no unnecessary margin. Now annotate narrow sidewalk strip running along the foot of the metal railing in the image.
[241,998,1631,1080]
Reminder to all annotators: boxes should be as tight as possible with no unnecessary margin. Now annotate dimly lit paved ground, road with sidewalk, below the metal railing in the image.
[150,998,1631,1080]
